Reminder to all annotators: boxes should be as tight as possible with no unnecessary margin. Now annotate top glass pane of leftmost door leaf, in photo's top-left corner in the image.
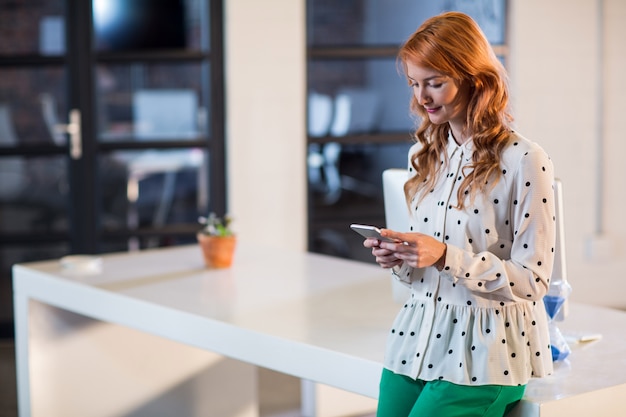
[0,0,65,55]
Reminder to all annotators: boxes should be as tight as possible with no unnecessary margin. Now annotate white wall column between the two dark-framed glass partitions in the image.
[224,0,307,250]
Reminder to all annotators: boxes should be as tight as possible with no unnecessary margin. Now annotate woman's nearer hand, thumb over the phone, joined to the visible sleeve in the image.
[380,229,446,270]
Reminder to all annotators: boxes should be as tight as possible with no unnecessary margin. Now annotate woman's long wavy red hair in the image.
[398,12,512,208]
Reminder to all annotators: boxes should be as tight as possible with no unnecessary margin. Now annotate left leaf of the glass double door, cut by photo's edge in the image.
[0,0,72,335]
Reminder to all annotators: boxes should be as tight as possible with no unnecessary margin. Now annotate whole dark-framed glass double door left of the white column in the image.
[0,0,226,337]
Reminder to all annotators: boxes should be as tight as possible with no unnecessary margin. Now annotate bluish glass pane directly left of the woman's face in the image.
[308,58,415,136]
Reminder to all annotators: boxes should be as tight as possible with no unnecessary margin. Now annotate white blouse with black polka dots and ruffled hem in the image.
[385,134,554,385]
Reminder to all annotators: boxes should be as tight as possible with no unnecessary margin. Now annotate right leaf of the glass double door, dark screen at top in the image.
[90,0,225,251]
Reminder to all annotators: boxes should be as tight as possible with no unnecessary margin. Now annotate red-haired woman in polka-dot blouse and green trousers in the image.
[364,12,555,417]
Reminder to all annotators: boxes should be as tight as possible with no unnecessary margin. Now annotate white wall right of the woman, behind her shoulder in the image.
[510,0,626,308]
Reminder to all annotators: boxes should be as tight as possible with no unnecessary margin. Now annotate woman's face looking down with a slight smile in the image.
[407,62,470,143]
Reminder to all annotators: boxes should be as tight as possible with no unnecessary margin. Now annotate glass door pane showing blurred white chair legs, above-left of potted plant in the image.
[100,149,208,230]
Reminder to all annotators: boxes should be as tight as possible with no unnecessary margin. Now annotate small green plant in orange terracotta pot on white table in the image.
[197,213,237,268]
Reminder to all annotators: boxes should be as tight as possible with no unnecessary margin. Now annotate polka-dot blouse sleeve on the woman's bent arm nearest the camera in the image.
[442,148,556,301]
